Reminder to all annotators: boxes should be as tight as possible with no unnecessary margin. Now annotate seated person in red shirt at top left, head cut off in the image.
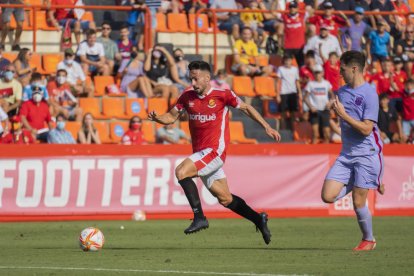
[46,0,96,45]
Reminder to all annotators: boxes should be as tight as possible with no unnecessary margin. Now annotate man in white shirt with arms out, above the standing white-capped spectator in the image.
[303,24,342,65]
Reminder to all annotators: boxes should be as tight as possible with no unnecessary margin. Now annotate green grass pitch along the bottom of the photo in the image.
[0,217,414,275]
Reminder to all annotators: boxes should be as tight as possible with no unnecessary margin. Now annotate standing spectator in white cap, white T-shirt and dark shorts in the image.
[305,64,332,144]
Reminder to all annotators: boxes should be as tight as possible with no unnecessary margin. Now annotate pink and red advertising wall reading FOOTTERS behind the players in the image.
[0,144,414,221]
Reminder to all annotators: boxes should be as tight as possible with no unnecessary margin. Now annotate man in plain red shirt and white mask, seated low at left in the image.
[20,87,53,143]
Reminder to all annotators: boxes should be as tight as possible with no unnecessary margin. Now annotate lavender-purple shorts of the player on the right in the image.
[326,153,384,189]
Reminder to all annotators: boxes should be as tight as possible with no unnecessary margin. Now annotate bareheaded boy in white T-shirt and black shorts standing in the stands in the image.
[276,55,302,130]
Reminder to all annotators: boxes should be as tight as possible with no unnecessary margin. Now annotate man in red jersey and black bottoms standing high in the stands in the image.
[278,1,306,65]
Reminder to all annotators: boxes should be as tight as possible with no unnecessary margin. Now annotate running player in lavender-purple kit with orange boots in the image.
[322,51,384,251]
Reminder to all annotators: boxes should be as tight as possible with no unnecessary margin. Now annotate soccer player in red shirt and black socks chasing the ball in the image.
[148,61,280,244]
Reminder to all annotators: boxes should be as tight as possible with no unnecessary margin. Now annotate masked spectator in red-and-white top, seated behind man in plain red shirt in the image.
[47,69,82,122]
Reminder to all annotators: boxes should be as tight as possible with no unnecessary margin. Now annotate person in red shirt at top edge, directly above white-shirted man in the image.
[308,1,351,36]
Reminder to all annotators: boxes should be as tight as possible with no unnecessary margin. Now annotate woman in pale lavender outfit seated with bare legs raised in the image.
[118,49,154,98]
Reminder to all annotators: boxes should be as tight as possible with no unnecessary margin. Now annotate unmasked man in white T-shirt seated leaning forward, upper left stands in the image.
[77,29,110,76]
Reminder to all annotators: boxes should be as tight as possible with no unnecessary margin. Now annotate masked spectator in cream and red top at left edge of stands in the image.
[0,64,22,115]
